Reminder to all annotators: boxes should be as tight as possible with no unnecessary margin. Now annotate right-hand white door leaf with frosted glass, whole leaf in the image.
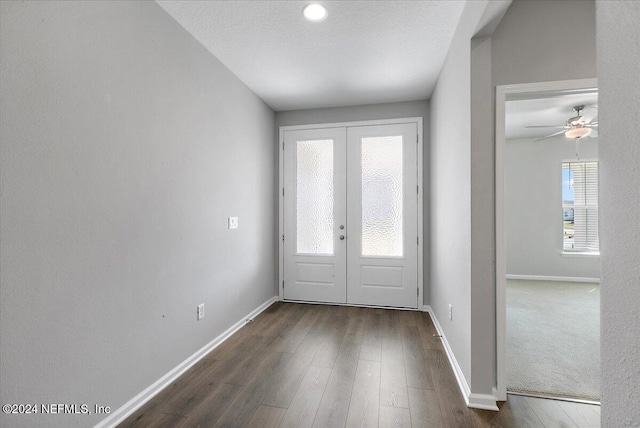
[345,123,418,308]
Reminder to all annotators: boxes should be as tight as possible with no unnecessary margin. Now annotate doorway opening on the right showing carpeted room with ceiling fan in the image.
[496,79,600,403]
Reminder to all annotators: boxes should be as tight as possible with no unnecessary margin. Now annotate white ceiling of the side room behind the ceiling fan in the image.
[505,91,598,140]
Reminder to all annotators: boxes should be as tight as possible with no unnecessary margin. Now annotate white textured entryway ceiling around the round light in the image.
[156,0,465,111]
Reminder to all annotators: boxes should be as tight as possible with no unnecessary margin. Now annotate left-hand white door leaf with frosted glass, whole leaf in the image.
[282,128,347,303]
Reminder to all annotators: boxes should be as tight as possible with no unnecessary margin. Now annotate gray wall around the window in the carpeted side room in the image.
[505,136,600,278]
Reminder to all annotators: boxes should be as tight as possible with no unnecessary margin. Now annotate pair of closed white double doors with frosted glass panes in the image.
[283,123,418,308]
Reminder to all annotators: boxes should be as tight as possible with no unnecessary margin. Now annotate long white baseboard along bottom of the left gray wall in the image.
[94,296,279,428]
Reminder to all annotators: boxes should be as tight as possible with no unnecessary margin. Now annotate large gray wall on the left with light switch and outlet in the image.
[0,1,277,427]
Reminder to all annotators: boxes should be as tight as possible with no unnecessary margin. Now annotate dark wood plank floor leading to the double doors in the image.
[120,303,600,428]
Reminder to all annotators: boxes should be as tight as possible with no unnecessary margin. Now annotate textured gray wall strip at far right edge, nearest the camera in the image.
[597,1,640,427]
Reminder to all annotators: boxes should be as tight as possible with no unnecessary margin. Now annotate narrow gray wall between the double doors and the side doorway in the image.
[430,2,484,392]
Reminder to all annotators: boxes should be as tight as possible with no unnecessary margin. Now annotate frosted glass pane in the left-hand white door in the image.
[296,140,334,254]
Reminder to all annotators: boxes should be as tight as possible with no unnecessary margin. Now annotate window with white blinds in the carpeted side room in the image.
[562,161,600,254]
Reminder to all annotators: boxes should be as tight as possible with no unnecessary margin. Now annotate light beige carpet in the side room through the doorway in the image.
[506,280,600,401]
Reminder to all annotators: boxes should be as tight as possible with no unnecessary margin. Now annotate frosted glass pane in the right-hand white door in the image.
[362,135,403,257]
